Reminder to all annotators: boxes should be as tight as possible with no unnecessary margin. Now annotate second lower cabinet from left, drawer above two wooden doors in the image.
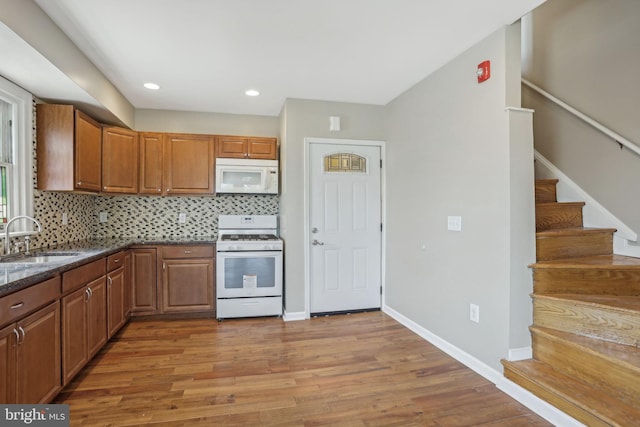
[62,259,107,385]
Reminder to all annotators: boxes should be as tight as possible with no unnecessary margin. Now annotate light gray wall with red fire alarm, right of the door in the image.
[386,28,533,370]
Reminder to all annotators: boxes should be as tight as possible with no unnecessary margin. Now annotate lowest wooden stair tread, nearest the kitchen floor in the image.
[502,359,640,426]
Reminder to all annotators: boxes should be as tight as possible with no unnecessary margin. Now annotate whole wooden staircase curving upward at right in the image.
[502,180,640,427]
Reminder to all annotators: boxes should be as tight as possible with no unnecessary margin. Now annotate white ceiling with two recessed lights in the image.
[15,0,543,116]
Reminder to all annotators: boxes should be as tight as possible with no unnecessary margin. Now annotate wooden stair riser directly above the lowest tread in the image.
[532,330,640,409]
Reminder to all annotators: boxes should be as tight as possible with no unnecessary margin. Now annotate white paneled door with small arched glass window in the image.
[309,143,382,313]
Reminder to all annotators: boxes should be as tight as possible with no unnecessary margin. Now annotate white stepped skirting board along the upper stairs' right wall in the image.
[534,151,638,242]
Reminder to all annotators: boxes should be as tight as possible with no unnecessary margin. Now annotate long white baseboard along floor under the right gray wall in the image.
[382,305,585,427]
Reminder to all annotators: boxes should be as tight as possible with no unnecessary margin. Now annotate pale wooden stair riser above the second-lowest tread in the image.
[533,297,640,346]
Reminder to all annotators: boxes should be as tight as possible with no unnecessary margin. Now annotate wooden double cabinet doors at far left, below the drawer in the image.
[0,301,61,404]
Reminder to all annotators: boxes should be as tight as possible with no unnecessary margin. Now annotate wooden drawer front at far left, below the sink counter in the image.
[0,276,60,326]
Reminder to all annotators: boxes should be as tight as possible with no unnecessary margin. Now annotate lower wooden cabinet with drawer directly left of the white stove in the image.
[161,245,215,314]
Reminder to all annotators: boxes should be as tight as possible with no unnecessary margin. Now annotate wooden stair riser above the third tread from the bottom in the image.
[533,268,640,296]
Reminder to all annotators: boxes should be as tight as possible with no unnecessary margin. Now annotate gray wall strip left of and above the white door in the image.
[280,99,385,313]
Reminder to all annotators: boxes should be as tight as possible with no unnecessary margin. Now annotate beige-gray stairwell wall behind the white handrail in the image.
[522,0,640,233]
